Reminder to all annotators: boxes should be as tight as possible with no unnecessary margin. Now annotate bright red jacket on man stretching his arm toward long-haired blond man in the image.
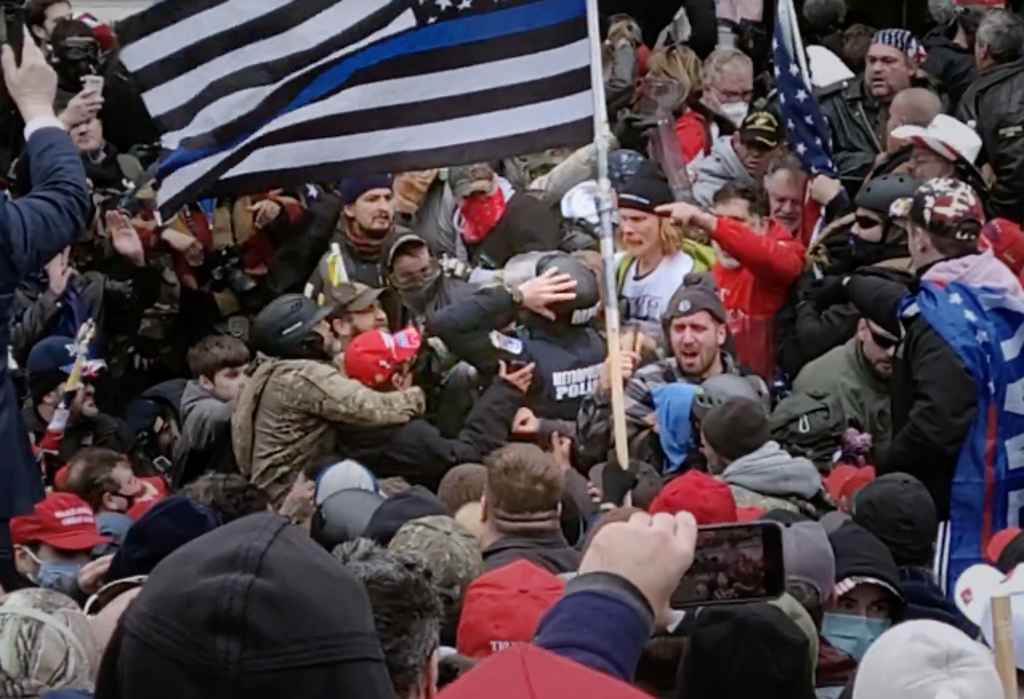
[712,217,807,381]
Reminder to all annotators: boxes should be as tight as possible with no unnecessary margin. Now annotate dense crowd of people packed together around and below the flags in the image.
[0,0,1024,699]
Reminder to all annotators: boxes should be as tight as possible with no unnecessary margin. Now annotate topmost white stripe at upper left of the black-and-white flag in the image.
[118,0,295,71]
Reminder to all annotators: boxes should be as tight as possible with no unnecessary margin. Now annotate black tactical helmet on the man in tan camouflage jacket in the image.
[251,294,331,359]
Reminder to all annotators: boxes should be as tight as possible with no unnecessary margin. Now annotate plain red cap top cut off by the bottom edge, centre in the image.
[438,645,649,699]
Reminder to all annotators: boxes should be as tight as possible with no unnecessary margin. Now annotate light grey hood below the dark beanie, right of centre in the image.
[719,441,823,512]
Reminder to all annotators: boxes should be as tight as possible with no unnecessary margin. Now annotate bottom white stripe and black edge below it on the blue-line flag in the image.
[161,93,594,212]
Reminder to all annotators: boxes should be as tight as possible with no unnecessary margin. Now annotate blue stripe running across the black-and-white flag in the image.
[158,0,587,179]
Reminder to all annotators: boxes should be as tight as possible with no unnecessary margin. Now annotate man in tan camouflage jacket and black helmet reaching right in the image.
[231,294,424,506]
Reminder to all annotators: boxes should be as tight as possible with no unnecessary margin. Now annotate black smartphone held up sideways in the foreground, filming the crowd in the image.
[672,522,785,609]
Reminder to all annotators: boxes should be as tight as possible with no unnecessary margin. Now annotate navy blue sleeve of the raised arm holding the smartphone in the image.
[534,573,654,683]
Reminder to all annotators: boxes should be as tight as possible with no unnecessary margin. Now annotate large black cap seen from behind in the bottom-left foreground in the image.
[95,514,394,699]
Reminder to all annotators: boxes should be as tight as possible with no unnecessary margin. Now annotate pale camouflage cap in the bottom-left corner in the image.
[0,587,101,699]
